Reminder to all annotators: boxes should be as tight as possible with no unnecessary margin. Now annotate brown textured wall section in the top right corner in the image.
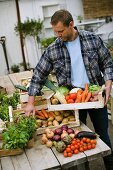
[83,0,113,19]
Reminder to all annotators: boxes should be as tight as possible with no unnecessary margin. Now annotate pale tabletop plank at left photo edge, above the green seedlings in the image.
[0,75,15,94]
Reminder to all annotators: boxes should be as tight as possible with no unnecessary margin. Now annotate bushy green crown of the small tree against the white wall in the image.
[14,18,43,37]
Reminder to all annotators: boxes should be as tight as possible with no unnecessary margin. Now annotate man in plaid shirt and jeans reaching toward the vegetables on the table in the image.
[25,10,113,150]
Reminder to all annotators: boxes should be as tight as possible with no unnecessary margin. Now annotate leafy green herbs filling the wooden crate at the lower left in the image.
[3,116,36,149]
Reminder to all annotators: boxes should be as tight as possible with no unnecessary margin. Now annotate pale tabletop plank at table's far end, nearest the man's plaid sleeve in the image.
[8,71,32,85]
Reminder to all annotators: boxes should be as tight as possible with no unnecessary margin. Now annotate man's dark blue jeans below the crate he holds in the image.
[79,107,112,148]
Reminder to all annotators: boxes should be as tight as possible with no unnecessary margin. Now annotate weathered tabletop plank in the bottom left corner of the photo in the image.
[0,157,15,170]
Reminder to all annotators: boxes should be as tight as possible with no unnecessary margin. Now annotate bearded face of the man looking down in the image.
[52,21,73,41]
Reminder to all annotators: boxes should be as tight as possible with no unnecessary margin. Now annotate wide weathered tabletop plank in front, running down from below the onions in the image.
[25,136,60,170]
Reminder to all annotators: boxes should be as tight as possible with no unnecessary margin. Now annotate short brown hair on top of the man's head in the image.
[51,9,73,26]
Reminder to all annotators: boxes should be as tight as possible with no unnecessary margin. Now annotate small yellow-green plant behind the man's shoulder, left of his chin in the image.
[41,37,56,48]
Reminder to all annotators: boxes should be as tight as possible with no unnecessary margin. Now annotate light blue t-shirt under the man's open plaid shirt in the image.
[65,36,89,88]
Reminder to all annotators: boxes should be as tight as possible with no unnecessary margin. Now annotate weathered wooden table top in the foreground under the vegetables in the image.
[0,124,111,170]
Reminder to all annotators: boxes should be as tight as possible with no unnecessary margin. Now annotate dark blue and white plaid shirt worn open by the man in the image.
[29,31,113,96]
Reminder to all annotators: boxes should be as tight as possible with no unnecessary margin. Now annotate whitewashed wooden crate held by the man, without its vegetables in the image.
[47,92,104,111]
